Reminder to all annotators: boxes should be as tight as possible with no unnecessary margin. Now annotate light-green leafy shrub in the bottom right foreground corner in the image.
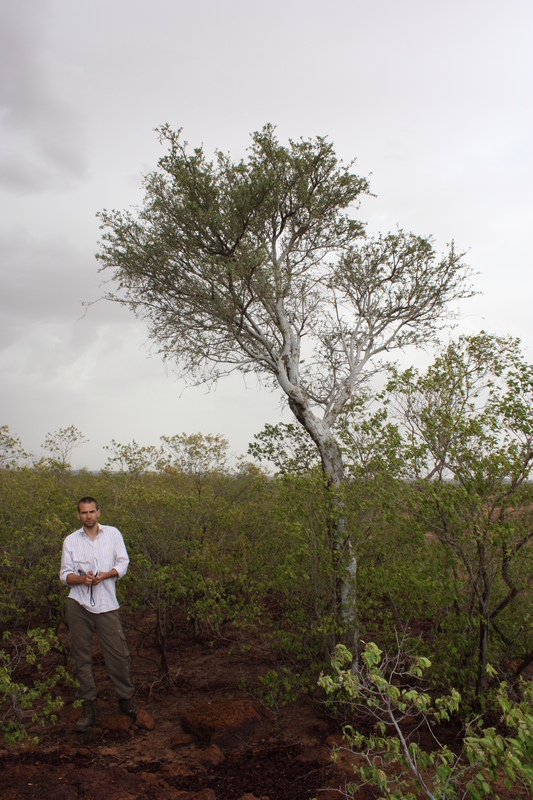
[319,642,533,800]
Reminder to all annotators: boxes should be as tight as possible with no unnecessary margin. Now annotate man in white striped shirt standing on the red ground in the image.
[59,497,137,733]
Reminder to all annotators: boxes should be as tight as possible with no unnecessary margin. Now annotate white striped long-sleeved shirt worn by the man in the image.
[59,525,130,614]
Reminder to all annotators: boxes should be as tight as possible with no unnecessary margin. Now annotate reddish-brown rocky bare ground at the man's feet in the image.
[0,615,516,800]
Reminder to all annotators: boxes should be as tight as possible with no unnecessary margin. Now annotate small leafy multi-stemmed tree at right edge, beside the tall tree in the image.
[389,332,533,697]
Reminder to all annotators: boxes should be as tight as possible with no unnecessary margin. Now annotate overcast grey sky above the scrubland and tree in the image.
[0,0,533,469]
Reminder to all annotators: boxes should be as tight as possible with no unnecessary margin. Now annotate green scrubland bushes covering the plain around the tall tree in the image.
[0,334,533,797]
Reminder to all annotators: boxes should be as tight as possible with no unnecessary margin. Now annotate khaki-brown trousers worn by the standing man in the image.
[67,597,135,700]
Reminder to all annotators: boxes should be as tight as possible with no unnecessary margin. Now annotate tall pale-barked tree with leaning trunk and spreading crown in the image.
[98,125,470,652]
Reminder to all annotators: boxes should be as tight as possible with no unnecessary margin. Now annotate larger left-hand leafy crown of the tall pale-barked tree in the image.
[99,125,368,388]
